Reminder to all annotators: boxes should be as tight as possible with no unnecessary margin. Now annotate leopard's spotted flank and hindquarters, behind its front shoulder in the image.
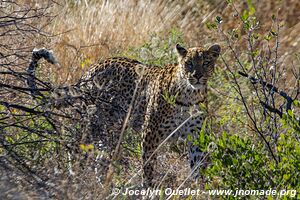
[79,58,164,132]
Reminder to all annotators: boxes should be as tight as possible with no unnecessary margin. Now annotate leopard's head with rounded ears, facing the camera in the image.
[176,44,221,89]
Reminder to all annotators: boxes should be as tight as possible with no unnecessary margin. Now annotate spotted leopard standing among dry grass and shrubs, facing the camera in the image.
[27,44,221,186]
